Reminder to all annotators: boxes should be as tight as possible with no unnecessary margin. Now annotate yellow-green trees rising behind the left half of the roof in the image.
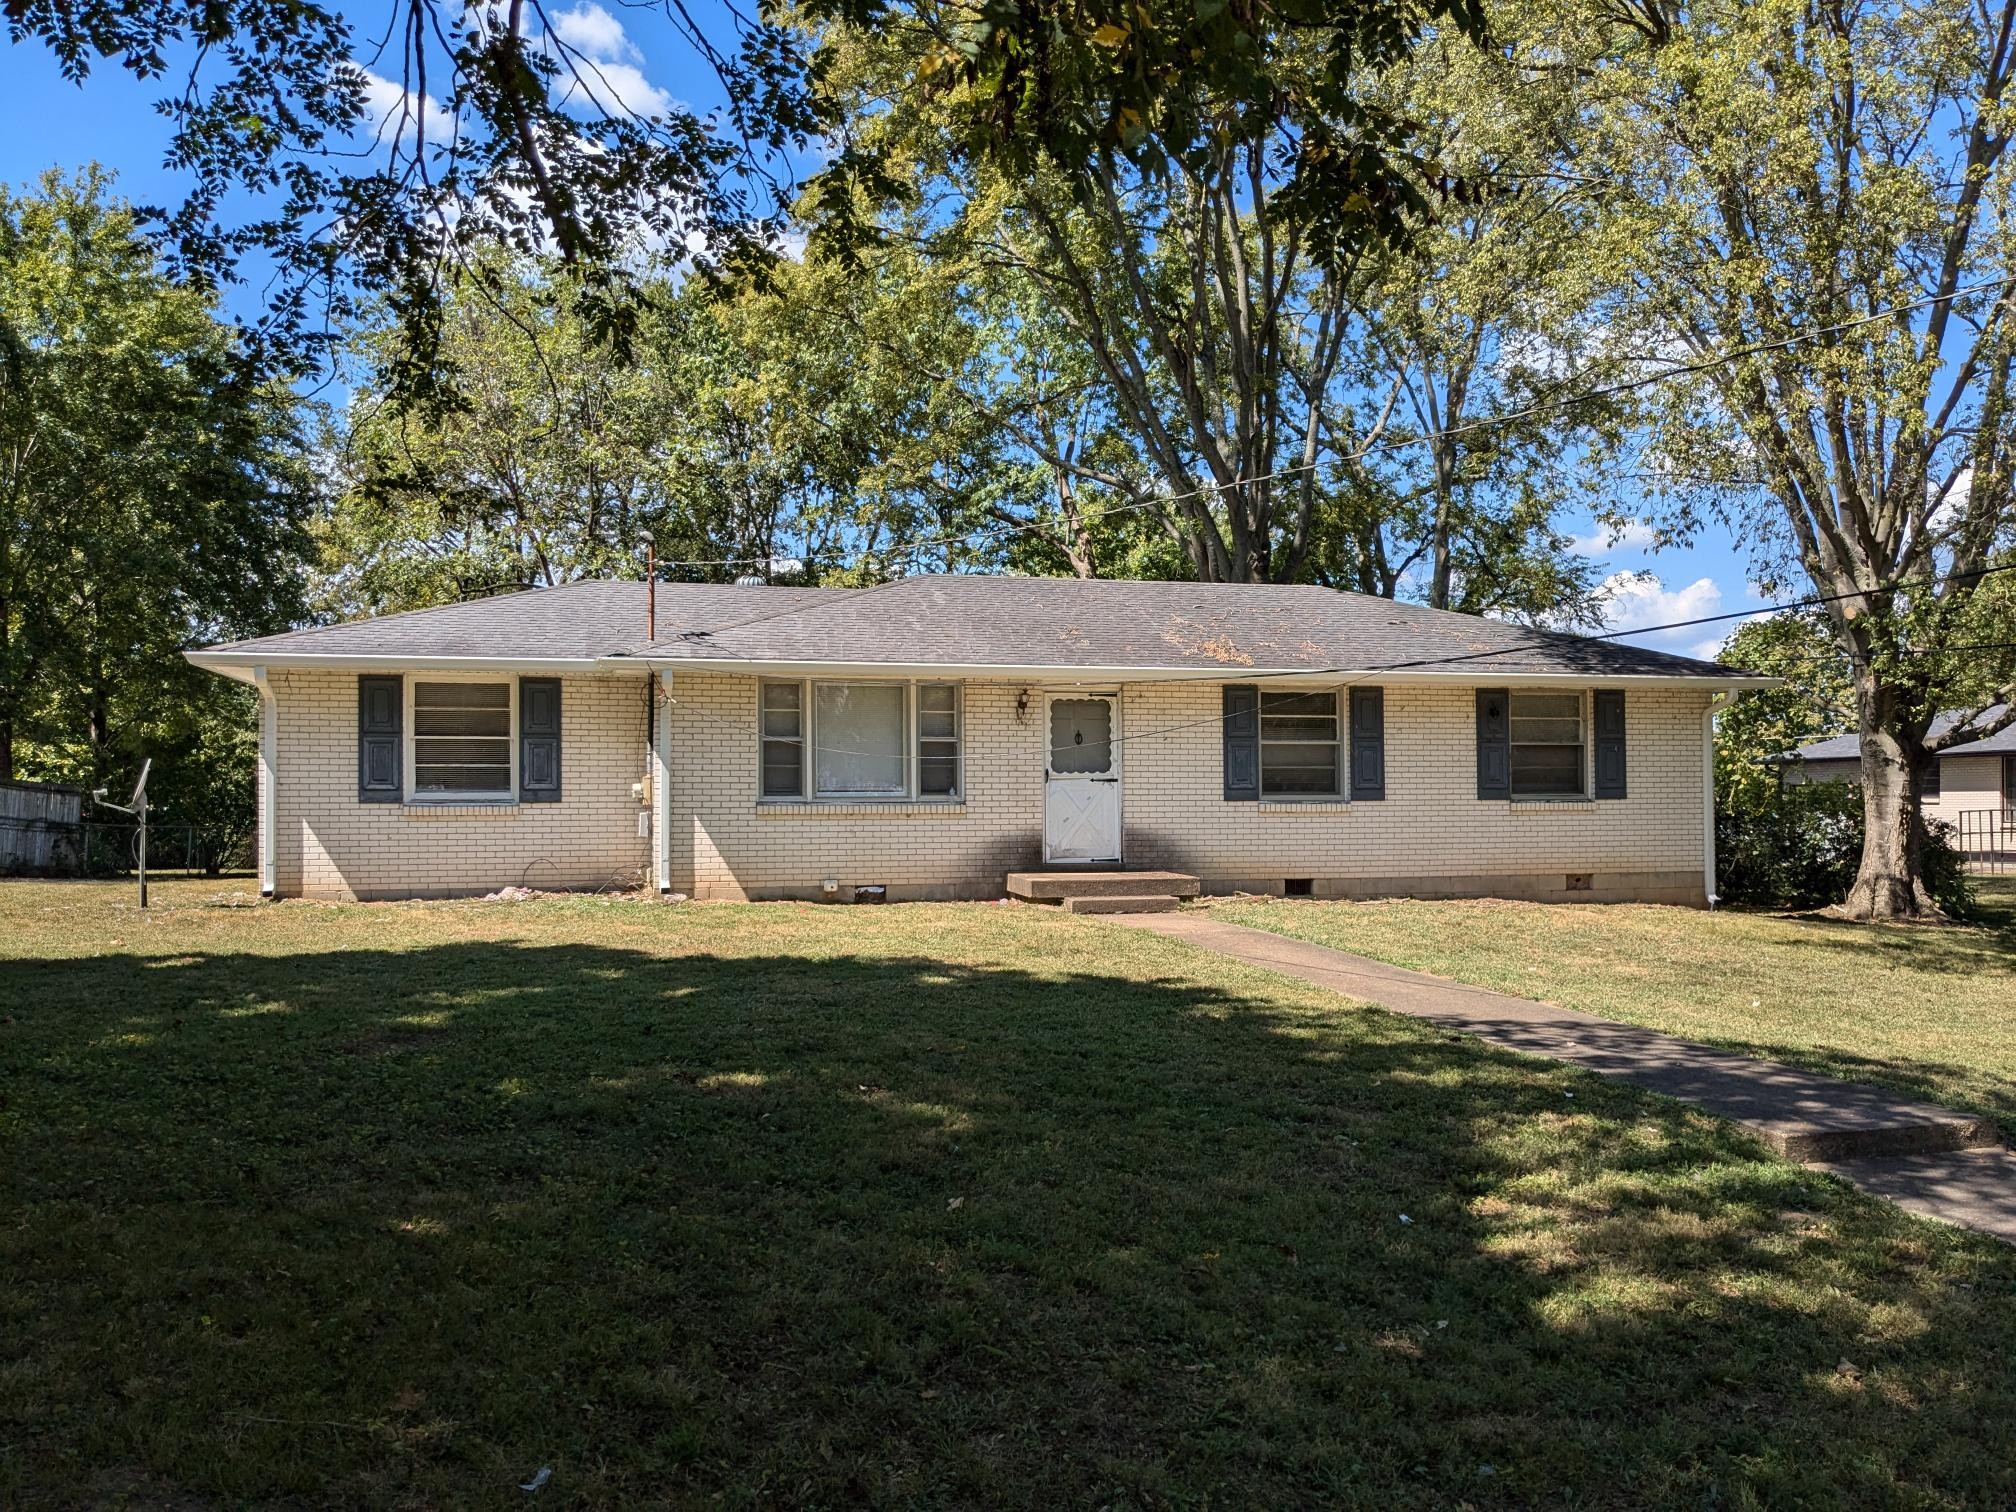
[319,254,990,613]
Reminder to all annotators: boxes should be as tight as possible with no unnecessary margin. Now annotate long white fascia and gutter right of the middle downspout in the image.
[628,657,1782,691]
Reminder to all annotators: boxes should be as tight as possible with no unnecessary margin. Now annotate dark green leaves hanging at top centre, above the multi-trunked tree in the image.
[806,0,1484,262]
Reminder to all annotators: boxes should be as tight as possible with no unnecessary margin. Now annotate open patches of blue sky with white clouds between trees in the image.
[0,0,1760,655]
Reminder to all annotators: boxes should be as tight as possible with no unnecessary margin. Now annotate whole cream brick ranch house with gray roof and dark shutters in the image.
[190,577,1770,903]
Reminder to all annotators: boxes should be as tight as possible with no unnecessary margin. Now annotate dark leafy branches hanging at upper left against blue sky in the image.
[6,0,823,391]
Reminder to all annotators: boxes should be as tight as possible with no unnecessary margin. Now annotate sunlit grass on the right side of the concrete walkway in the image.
[1212,877,2016,1137]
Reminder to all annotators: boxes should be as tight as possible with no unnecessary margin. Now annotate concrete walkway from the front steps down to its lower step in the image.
[1117,911,2016,1169]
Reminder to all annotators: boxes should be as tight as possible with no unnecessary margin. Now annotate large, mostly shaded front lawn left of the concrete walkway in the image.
[0,883,2016,1508]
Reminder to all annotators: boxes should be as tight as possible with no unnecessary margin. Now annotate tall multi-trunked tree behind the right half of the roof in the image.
[810,17,1597,615]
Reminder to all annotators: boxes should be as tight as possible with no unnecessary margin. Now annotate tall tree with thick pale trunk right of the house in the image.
[1564,0,2016,917]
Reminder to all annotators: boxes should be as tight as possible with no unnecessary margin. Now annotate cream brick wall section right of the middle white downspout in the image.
[653,673,1708,903]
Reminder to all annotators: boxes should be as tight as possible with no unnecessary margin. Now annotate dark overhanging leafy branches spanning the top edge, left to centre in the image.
[4,0,1482,397]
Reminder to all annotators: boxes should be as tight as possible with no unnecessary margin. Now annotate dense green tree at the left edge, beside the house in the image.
[0,171,308,827]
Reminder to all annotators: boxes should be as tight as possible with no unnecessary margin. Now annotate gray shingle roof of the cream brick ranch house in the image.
[192,575,1746,681]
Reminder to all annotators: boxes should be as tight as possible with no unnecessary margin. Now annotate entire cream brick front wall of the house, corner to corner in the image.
[260,673,1708,903]
